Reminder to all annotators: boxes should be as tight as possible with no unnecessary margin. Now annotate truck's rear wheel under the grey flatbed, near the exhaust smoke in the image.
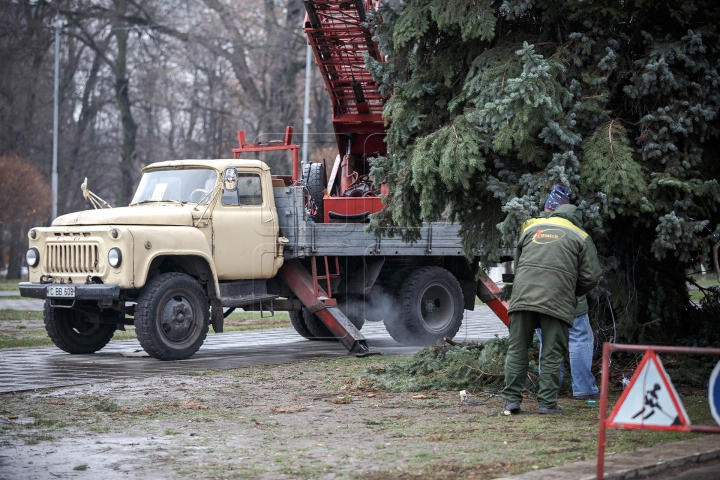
[385,267,464,345]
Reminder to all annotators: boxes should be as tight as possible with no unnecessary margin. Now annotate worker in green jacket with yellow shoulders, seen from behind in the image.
[502,185,600,415]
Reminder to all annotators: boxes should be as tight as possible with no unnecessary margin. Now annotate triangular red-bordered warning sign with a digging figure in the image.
[607,350,690,431]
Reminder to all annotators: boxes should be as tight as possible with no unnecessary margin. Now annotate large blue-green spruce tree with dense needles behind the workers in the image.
[366,0,720,345]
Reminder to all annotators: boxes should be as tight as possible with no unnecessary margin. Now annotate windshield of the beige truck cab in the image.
[130,168,218,205]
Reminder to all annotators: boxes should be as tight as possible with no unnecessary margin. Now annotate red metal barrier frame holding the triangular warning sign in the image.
[597,343,720,480]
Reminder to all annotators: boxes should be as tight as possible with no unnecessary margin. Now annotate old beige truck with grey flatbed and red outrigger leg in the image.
[20,159,496,360]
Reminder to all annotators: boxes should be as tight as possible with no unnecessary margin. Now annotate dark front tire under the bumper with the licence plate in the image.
[43,300,117,354]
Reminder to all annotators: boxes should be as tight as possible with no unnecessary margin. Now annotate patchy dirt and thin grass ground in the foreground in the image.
[0,356,709,480]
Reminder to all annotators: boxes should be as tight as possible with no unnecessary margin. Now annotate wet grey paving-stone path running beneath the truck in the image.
[0,305,508,393]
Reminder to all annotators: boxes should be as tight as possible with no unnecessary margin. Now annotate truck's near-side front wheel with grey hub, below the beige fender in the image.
[135,272,210,360]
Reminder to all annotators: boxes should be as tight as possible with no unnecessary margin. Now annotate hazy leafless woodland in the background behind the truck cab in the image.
[0,0,331,229]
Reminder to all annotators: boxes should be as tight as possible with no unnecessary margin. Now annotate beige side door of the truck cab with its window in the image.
[212,168,278,280]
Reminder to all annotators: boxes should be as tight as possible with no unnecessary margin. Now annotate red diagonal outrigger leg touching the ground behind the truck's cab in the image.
[278,259,370,356]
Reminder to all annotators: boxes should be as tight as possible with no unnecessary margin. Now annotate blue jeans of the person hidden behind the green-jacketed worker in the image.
[535,313,598,397]
